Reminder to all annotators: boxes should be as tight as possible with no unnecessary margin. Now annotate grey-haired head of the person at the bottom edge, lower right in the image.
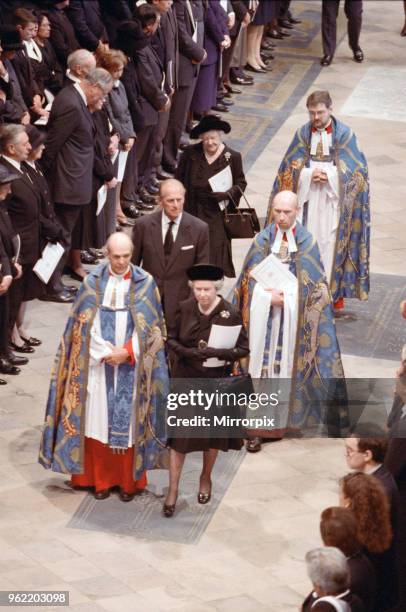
[302,546,365,612]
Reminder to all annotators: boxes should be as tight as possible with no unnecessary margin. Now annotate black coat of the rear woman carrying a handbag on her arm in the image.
[176,143,247,278]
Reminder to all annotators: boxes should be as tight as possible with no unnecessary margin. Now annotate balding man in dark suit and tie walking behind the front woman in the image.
[132,179,209,322]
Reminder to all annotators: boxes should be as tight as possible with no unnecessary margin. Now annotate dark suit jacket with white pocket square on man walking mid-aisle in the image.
[132,211,209,324]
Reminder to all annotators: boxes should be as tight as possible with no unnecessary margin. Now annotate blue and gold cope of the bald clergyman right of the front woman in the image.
[233,223,347,435]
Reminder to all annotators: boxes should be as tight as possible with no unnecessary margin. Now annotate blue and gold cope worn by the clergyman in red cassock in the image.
[39,264,169,480]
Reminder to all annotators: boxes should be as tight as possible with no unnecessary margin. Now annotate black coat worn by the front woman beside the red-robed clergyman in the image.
[167,297,249,453]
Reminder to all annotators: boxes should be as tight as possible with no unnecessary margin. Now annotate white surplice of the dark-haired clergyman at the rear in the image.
[297,132,340,284]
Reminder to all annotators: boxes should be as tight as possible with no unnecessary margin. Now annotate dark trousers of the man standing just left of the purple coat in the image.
[162,75,198,172]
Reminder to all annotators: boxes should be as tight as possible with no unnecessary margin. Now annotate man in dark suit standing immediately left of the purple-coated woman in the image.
[162,0,207,176]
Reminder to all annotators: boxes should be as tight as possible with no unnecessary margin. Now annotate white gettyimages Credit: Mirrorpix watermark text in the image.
[166,389,280,429]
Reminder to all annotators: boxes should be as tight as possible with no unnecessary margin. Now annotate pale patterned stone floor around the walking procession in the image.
[0,0,406,612]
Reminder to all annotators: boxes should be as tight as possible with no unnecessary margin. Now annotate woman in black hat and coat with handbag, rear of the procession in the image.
[176,115,247,278]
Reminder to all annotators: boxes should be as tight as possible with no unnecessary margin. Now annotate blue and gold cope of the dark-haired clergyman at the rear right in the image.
[267,92,370,303]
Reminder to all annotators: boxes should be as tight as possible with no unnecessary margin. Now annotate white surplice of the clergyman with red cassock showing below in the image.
[85,273,140,447]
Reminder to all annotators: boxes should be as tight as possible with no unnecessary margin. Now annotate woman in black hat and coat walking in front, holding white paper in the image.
[163,264,249,518]
